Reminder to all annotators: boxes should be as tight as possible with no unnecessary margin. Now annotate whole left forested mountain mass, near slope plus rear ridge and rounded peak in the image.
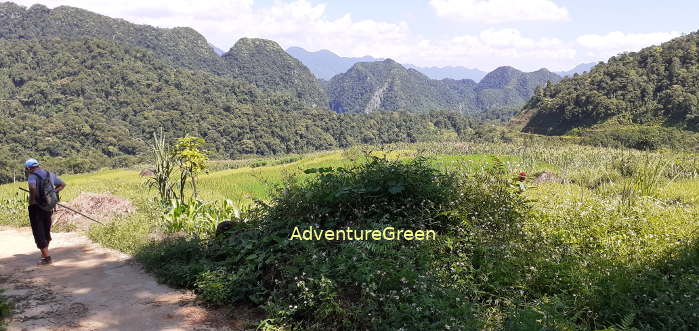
[0,3,471,182]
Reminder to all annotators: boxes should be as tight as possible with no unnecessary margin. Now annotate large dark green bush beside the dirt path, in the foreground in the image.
[139,158,528,329]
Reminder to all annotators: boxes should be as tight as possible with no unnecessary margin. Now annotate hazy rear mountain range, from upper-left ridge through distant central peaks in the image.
[0,3,592,119]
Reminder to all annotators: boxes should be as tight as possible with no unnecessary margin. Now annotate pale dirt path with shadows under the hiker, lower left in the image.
[0,229,239,330]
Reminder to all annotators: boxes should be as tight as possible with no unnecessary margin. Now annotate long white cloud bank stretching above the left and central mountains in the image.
[10,0,575,69]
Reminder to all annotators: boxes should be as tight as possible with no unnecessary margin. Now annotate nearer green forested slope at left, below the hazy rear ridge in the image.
[0,38,469,182]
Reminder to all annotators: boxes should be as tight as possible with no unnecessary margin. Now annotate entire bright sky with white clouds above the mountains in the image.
[9,0,699,71]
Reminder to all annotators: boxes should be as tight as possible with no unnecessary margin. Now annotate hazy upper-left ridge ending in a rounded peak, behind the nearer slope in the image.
[0,2,327,107]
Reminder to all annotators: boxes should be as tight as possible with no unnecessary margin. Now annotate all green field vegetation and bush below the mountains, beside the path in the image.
[0,136,699,330]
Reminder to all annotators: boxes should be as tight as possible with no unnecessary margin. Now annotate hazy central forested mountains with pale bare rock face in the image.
[328,59,560,119]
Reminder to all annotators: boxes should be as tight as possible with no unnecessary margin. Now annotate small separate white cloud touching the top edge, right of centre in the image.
[430,0,569,24]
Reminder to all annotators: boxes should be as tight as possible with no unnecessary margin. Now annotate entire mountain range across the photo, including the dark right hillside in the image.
[0,3,699,181]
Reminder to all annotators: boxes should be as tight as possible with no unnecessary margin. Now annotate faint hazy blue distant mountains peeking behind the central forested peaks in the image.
[286,47,486,82]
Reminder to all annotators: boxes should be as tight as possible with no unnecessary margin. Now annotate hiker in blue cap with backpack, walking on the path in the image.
[24,159,66,265]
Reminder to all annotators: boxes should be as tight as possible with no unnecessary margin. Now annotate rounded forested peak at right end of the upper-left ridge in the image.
[223,38,328,108]
